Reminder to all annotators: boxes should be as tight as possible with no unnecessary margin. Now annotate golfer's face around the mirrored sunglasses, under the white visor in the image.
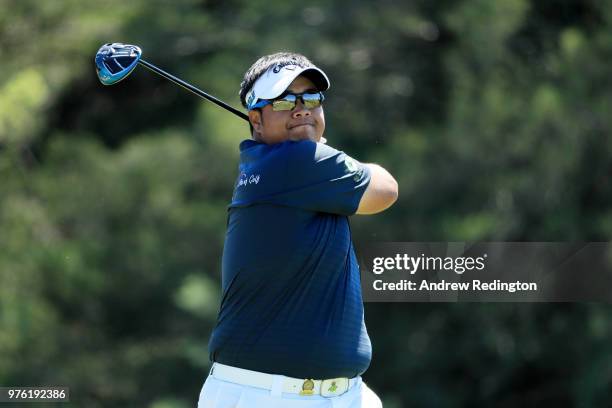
[249,75,325,144]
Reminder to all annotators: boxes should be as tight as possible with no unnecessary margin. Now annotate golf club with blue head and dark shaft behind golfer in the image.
[95,43,249,122]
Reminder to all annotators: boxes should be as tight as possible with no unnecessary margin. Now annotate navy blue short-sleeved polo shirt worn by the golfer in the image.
[209,140,372,379]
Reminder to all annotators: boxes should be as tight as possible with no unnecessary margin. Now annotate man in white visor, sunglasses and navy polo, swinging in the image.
[198,53,398,408]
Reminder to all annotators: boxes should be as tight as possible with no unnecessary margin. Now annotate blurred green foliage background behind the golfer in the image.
[0,0,612,408]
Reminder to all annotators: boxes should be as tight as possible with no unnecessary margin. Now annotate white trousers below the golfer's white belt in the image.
[198,376,382,408]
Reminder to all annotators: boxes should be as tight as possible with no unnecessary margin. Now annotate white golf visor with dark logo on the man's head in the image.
[244,64,330,110]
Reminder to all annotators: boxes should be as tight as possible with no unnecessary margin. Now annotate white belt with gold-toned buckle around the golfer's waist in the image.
[210,363,359,397]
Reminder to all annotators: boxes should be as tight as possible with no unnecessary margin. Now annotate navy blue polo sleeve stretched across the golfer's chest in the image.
[270,141,370,215]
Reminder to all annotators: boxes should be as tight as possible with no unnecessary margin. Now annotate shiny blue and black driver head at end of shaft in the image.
[96,43,142,85]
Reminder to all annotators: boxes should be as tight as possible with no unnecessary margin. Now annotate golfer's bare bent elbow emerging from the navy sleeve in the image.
[356,163,398,215]
